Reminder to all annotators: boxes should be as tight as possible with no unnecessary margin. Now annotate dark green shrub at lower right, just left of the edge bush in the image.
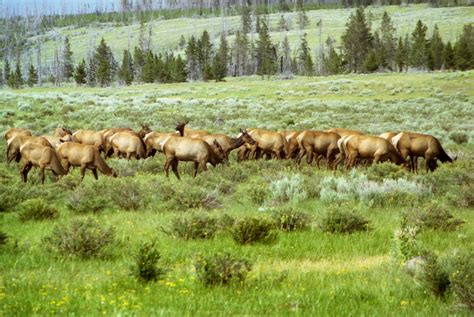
[415,252,450,297]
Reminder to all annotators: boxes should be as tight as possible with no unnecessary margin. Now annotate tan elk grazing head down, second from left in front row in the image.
[57,143,117,179]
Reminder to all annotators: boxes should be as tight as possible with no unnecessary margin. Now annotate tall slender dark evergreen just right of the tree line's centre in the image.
[257,21,276,76]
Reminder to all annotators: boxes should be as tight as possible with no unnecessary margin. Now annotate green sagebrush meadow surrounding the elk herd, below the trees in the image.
[0,70,474,316]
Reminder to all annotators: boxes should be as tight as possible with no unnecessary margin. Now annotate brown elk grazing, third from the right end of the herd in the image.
[296,131,341,168]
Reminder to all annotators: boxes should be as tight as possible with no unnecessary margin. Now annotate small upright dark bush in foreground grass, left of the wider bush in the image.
[132,242,165,282]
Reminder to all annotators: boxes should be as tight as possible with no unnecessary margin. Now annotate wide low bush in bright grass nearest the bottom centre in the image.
[194,253,252,286]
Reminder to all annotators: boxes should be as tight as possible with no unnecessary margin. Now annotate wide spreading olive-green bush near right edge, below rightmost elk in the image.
[402,205,464,231]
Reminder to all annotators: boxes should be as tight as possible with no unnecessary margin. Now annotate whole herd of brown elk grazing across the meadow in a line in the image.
[4,122,453,183]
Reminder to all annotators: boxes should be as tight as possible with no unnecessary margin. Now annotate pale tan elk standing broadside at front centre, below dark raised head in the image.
[163,137,227,179]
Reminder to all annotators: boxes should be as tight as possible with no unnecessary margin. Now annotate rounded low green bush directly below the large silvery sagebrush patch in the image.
[319,208,369,233]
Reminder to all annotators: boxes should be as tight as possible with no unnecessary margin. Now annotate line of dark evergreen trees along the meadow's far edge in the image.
[1,7,474,88]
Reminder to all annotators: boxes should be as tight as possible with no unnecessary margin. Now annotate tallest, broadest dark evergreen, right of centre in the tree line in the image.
[341,7,373,72]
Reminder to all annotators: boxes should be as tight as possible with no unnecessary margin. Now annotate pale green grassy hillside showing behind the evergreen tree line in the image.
[29,4,474,62]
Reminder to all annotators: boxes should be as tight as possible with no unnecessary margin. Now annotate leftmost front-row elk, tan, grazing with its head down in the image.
[20,143,67,184]
